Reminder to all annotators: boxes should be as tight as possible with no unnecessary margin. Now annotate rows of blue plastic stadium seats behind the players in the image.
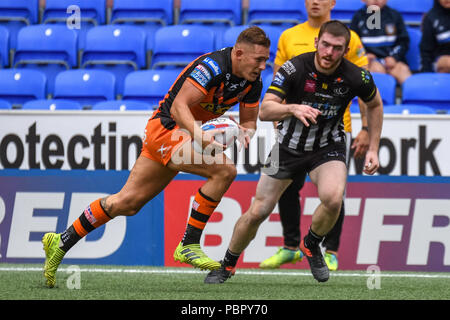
[0,0,444,113]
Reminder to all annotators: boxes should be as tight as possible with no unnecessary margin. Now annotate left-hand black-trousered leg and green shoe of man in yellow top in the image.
[259,173,306,269]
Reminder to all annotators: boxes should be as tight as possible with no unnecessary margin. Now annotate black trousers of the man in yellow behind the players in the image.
[278,171,345,251]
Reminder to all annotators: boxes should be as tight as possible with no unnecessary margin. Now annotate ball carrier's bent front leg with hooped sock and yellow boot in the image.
[168,144,237,270]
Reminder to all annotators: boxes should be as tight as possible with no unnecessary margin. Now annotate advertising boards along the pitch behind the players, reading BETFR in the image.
[0,111,450,271]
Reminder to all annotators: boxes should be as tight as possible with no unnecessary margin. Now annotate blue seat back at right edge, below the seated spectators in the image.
[402,73,450,110]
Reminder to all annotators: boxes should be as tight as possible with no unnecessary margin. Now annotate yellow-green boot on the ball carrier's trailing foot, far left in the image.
[42,233,66,288]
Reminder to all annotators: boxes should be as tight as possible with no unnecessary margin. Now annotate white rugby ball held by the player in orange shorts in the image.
[193,117,239,153]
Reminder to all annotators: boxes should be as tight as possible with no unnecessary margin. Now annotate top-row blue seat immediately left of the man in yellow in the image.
[247,0,307,28]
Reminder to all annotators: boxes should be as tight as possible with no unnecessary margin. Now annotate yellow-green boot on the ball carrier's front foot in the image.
[173,242,220,270]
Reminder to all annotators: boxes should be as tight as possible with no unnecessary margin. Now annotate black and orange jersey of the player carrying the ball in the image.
[154,47,262,129]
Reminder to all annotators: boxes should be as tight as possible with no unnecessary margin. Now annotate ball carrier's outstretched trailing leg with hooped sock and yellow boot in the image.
[42,155,177,287]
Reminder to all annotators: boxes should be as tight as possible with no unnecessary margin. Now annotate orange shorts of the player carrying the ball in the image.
[141,117,191,165]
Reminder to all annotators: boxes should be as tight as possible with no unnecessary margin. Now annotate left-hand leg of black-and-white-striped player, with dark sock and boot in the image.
[205,174,292,283]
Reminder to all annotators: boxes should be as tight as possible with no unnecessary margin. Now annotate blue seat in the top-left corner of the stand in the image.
[0,0,39,49]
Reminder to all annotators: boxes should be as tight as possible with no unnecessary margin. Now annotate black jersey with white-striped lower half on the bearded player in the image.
[267,52,377,152]
